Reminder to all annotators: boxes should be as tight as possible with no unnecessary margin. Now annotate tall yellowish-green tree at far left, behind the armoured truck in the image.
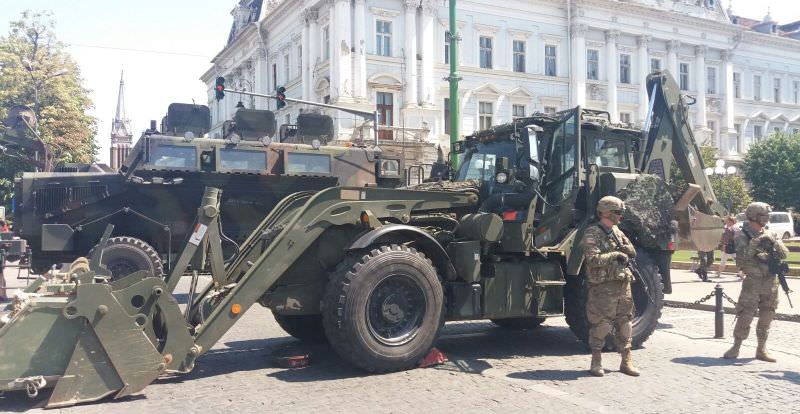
[0,10,97,212]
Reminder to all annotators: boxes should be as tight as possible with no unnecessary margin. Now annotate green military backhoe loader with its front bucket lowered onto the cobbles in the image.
[0,73,722,407]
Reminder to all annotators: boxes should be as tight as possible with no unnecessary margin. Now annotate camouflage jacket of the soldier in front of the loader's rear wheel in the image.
[581,223,636,284]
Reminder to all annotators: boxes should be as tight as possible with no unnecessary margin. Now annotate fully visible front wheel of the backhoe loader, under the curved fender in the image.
[322,244,444,372]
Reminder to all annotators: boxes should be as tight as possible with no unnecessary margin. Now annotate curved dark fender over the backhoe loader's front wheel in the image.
[347,224,456,280]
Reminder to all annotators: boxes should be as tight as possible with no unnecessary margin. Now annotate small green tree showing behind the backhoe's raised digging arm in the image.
[670,147,752,214]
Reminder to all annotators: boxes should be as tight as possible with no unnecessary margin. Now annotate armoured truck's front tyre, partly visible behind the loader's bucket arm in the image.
[89,236,164,281]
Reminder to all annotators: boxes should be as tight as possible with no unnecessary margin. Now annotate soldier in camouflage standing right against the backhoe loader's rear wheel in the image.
[581,196,639,377]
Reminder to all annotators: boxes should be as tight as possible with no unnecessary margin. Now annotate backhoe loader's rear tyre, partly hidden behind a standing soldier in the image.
[564,251,664,350]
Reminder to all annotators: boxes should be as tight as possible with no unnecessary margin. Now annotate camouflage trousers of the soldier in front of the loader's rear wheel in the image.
[586,280,633,350]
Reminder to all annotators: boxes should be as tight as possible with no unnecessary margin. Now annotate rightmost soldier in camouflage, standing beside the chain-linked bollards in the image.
[723,202,789,362]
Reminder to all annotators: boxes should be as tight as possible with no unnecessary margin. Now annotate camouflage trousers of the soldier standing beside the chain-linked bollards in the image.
[733,276,778,340]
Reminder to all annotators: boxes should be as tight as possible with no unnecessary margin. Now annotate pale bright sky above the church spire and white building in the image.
[0,0,800,163]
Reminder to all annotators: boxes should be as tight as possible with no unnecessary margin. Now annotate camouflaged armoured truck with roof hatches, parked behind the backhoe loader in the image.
[15,104,403,275]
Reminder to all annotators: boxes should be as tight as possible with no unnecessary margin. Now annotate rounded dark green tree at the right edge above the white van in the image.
[744,133,800,210]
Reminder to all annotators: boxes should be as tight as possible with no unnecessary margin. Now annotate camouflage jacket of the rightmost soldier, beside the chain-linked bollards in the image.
[733,223,789,277]
